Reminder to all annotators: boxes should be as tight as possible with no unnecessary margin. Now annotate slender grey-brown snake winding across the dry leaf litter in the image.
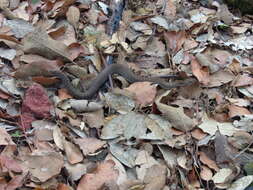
[50,64,196,99]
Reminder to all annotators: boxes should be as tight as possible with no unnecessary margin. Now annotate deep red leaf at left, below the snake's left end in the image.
[21,84,52,129]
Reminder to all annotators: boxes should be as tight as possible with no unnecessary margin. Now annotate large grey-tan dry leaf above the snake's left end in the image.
[22,28,73,62]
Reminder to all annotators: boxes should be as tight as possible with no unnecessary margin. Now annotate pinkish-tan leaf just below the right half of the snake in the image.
[125,82,156,106]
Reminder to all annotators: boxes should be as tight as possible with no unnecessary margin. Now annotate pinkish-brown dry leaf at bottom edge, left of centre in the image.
[77,160,118,190]
